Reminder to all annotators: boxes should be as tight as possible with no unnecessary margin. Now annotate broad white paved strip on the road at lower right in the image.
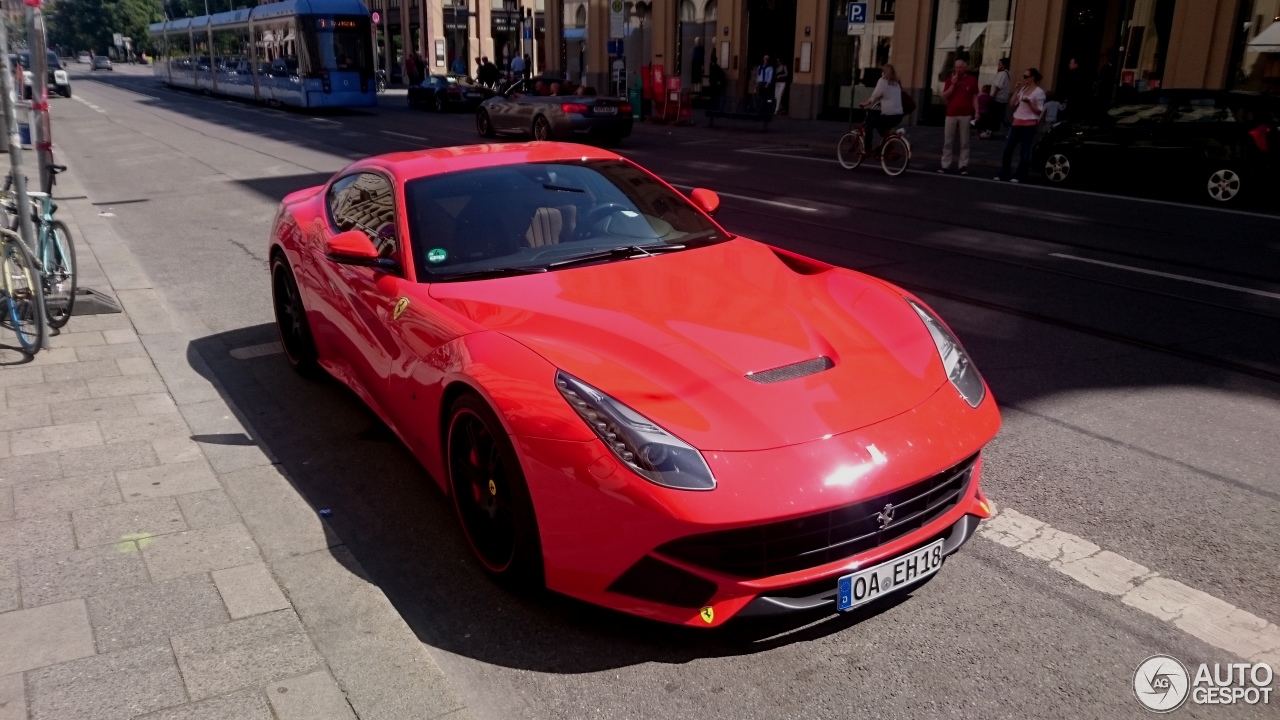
[978,507,1280,671]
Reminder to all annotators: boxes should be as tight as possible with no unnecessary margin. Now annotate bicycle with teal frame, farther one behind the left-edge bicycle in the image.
[0,165,76,328]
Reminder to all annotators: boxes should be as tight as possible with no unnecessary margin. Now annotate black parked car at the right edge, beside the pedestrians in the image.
[1033,90,1280,205]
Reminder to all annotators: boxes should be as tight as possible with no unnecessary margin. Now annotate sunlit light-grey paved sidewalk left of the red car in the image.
[0,159,468,720]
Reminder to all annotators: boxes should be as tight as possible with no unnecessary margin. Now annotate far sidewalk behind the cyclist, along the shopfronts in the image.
[632,116,1016,177]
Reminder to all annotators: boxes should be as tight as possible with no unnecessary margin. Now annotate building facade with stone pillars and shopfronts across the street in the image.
[370,0,1280,123]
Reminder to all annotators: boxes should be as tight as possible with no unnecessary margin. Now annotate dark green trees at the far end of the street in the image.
[47,0,164,54]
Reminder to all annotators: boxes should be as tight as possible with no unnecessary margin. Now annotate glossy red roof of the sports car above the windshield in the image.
[343,142,621,182]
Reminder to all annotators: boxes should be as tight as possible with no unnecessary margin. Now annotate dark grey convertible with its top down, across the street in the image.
[476,78,631,143]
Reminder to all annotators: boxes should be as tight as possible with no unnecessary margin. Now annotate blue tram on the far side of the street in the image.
[150,0,378,108]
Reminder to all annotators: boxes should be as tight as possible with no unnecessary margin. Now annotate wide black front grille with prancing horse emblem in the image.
[658,455,978,578]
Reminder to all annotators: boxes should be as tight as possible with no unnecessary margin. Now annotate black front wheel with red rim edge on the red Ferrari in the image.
[445,393,543,589]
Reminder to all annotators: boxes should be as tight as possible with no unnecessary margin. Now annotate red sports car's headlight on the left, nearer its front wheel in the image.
[556,370,716,489]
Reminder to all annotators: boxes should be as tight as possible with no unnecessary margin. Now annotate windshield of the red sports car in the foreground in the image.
[404,160,726,282]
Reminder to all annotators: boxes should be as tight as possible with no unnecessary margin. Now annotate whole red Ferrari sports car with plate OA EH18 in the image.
[270,142,1000,626]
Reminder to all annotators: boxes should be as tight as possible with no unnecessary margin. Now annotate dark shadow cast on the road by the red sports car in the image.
[188,325,928,673]
